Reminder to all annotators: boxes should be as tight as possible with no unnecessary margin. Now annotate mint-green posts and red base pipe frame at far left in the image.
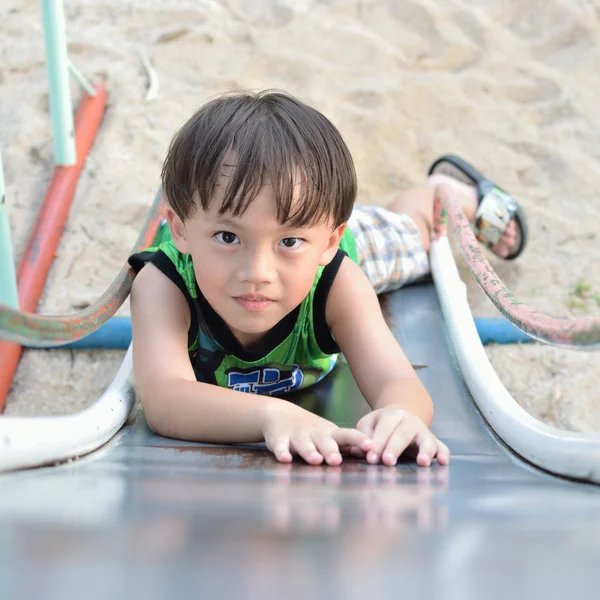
[0,0,107,412]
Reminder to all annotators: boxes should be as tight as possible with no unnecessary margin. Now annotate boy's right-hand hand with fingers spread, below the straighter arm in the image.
[352,404,450,467]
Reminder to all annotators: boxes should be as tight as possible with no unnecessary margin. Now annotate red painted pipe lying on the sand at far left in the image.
[0,84,107,412]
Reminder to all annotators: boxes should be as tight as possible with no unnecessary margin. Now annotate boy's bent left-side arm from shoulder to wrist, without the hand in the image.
[131,264,264,442]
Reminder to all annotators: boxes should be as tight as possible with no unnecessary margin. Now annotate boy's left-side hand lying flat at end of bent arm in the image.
[263,400,373,465]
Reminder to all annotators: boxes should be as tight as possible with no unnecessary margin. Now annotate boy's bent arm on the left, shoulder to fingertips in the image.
[131,264,370,464]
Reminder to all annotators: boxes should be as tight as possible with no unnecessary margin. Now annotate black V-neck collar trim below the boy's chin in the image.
[196,283,301,362]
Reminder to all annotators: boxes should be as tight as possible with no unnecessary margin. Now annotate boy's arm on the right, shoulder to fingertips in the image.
[326,259,447,464]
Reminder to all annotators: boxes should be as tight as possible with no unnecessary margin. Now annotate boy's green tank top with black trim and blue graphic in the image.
[129,223,358,395]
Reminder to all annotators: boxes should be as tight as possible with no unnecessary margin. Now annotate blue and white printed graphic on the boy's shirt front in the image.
[225,364,304,395]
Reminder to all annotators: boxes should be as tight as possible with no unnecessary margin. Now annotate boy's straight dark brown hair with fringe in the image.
[162,90,356,227]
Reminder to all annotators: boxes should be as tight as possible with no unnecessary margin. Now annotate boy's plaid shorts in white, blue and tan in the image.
[348,204,429,294]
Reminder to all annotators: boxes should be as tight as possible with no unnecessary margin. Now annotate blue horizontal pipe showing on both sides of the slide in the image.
[30,317,533,350]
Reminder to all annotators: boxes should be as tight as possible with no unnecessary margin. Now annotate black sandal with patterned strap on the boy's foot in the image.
[429,154,527,260]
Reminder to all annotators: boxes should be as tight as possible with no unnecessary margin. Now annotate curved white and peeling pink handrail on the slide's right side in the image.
[430,186,600,483]
